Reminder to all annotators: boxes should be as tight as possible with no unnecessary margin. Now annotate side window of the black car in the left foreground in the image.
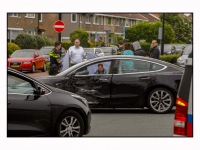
[8,74,37,95]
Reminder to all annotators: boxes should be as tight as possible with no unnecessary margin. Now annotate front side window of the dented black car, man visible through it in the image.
[75,61,111,75]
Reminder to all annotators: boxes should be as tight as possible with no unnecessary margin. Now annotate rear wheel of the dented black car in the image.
[147,88,174,114]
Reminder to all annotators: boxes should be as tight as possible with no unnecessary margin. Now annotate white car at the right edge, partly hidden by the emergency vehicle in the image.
[177,45,192,67]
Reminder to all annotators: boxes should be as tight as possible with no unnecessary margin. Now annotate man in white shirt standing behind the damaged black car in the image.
[69,39,86,66]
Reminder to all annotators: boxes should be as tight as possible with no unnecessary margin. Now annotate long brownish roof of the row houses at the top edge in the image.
[100,13,147,20]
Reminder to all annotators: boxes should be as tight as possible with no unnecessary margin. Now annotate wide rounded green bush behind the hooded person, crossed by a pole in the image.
[125,21,174,44]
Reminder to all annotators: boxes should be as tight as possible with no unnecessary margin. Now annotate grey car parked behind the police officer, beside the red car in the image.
[40,46,66,62]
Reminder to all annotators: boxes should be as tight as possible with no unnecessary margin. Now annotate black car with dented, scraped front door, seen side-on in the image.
[38,55,184,113]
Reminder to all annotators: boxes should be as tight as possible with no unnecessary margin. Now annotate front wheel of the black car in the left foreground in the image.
[56,110,84,137]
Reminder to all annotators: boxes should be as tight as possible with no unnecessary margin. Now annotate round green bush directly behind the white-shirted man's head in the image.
[70,29,89,47]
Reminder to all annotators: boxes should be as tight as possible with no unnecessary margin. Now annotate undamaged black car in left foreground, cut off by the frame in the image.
[7,68,91,137]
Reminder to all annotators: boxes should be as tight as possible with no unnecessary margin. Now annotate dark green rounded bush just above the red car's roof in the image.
[15,33,37,49]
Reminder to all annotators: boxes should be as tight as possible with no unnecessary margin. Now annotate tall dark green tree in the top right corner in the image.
[159,13,192,43]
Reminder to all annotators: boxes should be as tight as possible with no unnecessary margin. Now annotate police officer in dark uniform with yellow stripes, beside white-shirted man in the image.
[49,41,63,75]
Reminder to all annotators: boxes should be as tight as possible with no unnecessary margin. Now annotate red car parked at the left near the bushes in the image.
[8,49,46,72]
